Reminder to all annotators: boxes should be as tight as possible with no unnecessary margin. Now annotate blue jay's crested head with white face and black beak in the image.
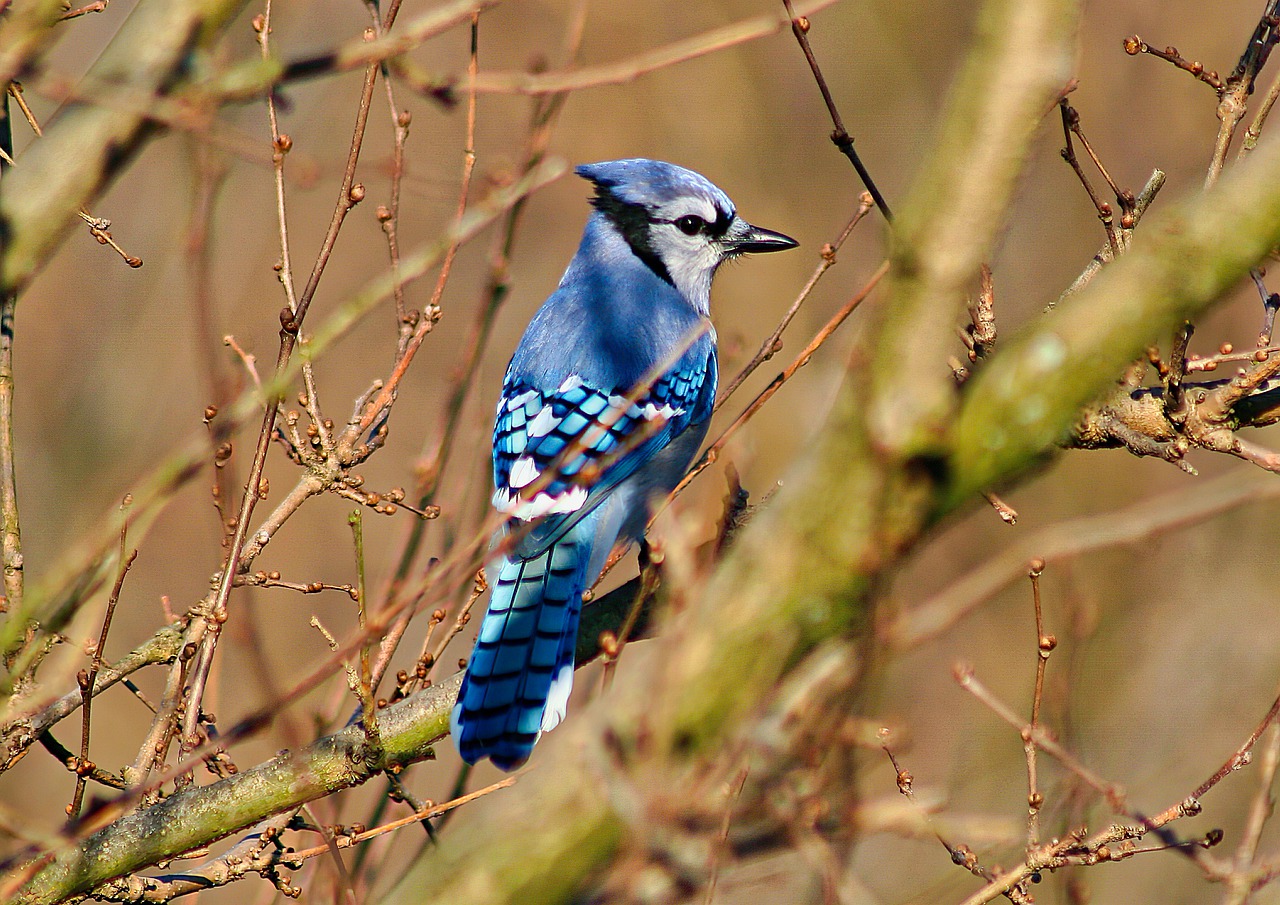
[575,157,797,308]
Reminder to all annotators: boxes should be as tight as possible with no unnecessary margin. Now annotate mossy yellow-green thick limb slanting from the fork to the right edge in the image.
[946,131,1280,506]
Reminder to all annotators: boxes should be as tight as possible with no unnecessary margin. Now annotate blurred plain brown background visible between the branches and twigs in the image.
[0,0,1280,902]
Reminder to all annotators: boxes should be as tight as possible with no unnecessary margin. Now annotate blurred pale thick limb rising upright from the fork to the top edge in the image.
[868,0,1078,454]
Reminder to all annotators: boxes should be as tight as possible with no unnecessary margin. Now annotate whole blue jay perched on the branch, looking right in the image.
[451,159,796,771]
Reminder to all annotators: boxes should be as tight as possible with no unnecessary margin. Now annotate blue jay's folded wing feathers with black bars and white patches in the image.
[493,353,716,557]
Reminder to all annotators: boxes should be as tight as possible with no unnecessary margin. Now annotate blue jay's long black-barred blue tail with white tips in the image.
[449,518,594,769]
